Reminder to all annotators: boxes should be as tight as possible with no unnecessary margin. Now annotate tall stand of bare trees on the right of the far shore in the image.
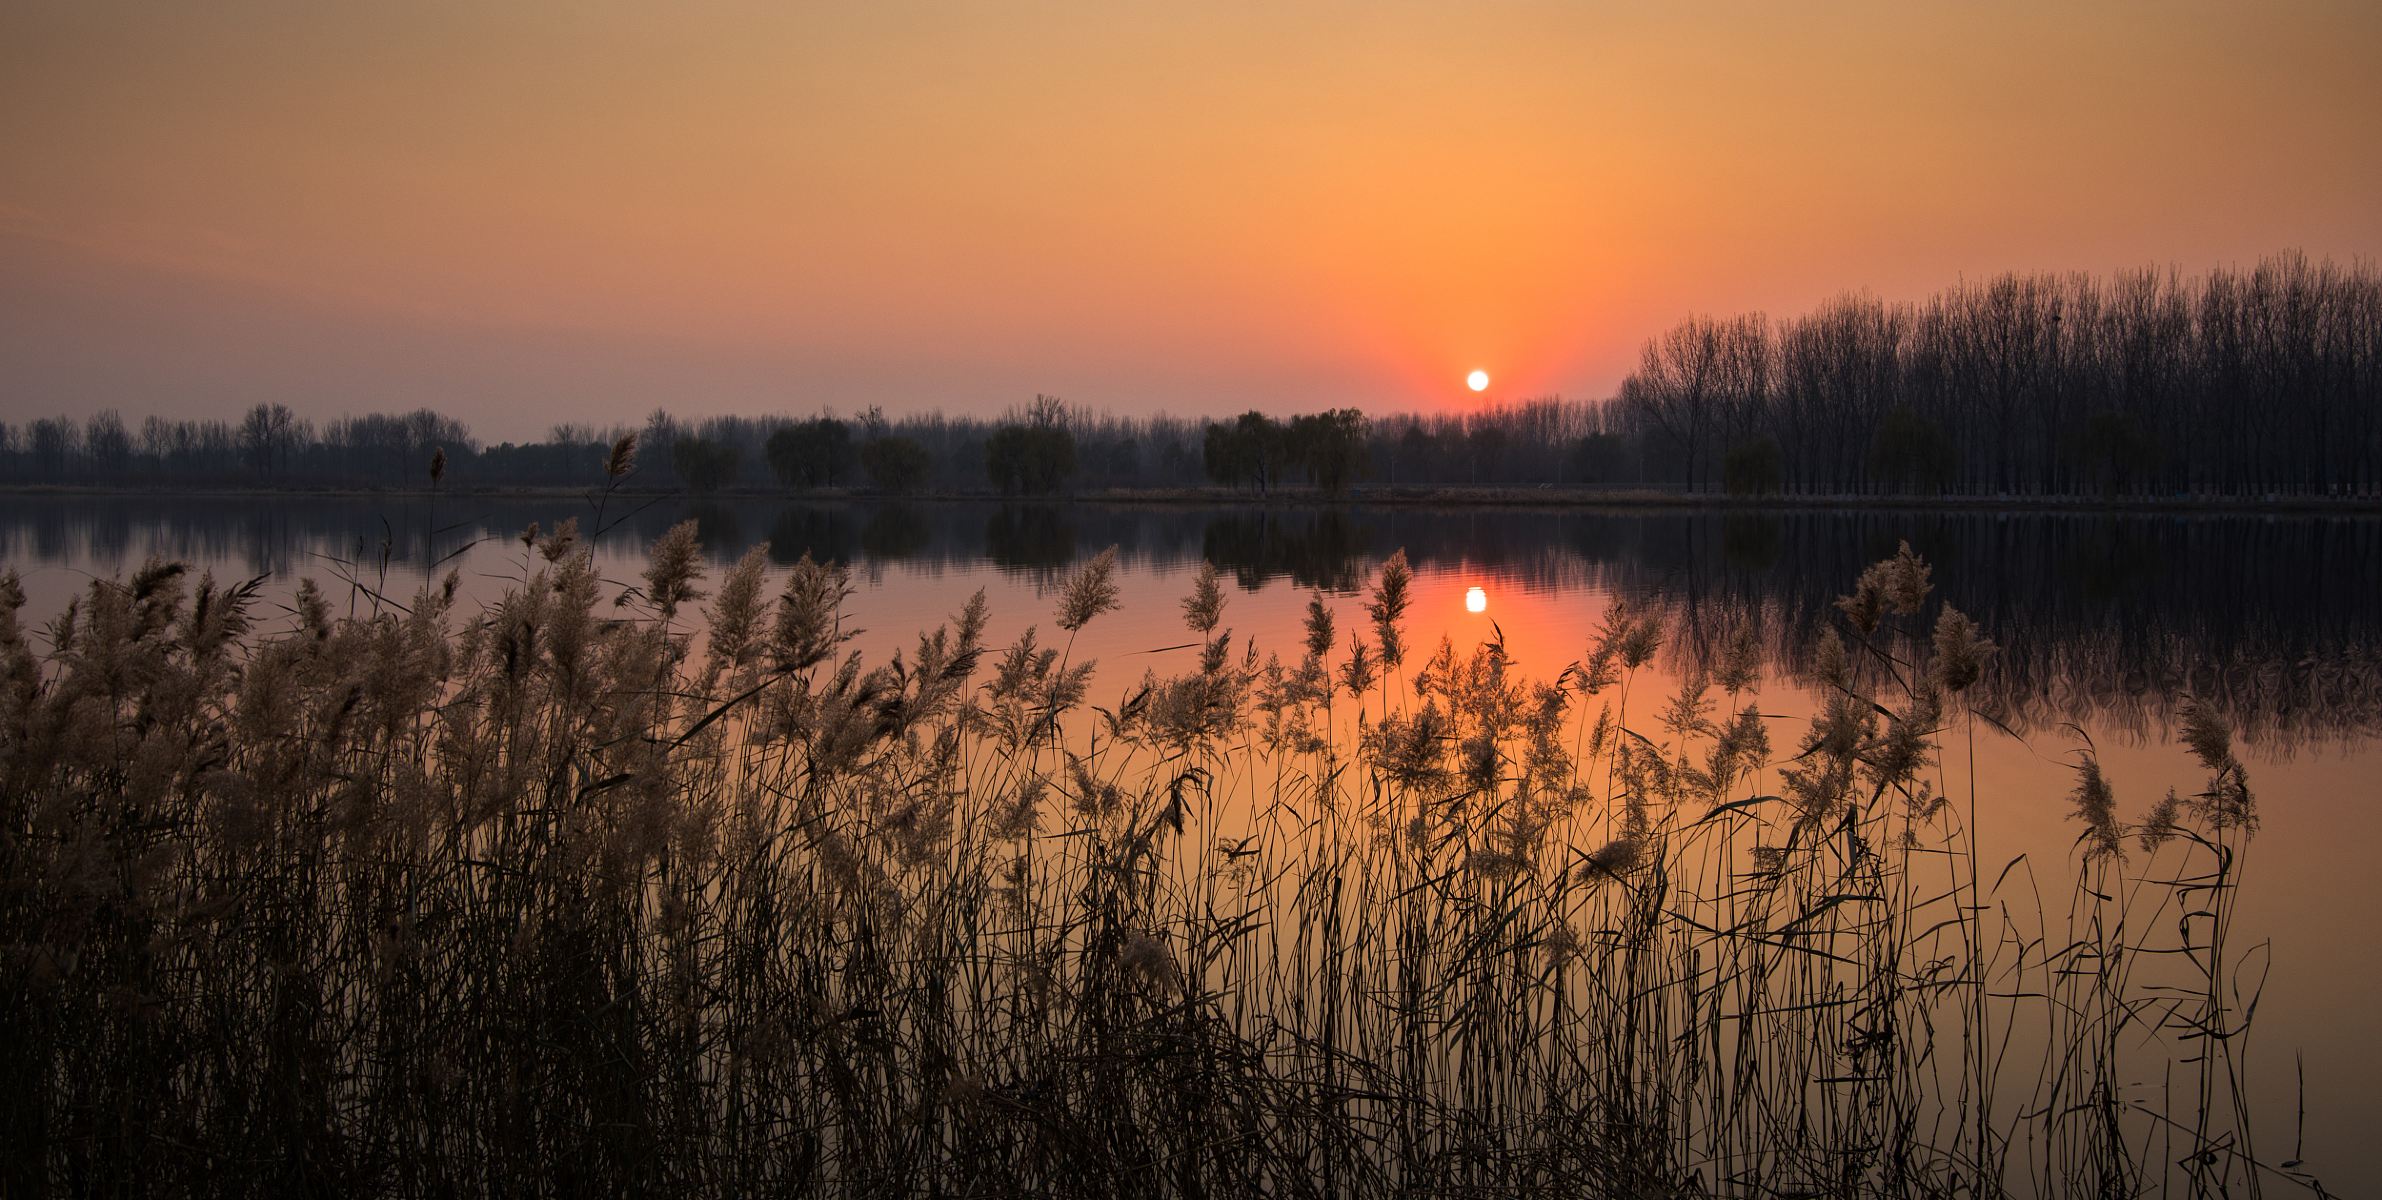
[1617,252,2382,495]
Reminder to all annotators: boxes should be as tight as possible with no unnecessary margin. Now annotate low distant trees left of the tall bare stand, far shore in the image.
[0,395,1641,495]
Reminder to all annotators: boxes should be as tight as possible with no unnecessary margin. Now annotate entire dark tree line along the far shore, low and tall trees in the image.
[0,252,2382,498]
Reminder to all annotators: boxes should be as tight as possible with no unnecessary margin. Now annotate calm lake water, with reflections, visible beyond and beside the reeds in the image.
[0,498,2382,1195]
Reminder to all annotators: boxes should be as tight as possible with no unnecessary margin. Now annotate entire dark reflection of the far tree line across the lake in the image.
[0,498,2382,745]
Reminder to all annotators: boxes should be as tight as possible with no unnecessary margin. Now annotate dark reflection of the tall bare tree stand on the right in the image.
[1648,517,2382,752]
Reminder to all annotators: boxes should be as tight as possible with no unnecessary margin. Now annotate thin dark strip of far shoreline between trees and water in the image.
[0,483,2382,517]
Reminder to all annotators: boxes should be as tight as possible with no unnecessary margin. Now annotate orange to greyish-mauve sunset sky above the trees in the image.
[0,0,2382,438]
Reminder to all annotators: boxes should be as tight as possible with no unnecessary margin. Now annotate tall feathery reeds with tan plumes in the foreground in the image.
[0,524,2301,1195]
